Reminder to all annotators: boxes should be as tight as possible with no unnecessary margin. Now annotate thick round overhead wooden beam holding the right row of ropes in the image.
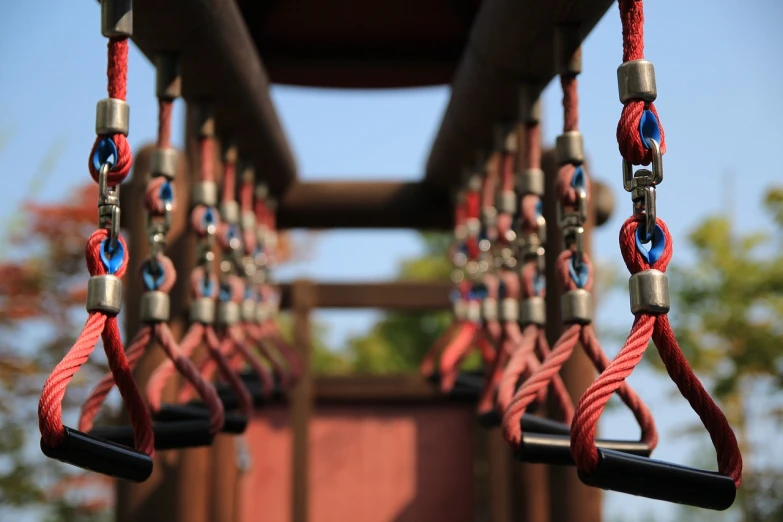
[425,0,613,189]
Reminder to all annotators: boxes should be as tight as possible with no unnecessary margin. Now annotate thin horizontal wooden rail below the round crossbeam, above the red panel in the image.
[279,281,453,311]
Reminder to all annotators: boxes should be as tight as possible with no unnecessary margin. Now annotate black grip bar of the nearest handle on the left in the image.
[41,427,152,482]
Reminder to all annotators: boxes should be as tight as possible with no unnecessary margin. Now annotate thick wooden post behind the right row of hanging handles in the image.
[542,151,601,522]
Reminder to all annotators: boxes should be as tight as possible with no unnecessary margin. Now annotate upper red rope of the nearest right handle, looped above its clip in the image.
[617,0,666,165]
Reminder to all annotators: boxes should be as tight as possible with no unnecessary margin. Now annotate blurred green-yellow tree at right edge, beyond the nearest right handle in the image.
[670,188,783,522]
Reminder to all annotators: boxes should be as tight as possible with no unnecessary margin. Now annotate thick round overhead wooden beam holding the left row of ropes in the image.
[105,0,296,194]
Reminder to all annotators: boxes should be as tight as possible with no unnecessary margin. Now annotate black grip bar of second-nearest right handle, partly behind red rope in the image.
[514,433,651,466]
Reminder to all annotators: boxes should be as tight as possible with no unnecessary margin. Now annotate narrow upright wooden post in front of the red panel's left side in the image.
[290,281,317,522]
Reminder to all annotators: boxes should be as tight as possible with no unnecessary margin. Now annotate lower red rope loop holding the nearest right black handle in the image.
[571,217,742,487]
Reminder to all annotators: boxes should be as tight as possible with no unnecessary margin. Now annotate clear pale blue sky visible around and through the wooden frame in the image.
[0,0,783,521]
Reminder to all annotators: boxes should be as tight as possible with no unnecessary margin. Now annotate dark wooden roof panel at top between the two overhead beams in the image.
[237,0,480,89]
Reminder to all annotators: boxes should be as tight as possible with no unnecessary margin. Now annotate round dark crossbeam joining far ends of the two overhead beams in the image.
[278,181,453,230]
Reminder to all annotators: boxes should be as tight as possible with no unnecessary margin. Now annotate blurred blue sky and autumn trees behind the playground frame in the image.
[0,0,783,522]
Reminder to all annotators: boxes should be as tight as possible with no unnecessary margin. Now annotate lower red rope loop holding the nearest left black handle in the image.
[38,230,154,455]
